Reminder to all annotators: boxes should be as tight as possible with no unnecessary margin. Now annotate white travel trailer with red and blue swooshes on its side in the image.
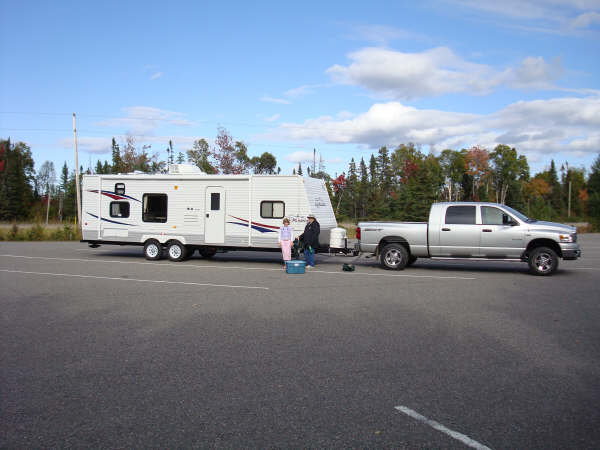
[82,165,346,261]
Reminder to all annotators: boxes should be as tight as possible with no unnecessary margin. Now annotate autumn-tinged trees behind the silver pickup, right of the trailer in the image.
[332,144,600,225]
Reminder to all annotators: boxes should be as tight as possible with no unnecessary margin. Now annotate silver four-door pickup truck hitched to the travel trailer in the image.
[356,202,581,275]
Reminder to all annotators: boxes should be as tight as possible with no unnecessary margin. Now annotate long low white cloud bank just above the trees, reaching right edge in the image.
[274,97,600,162]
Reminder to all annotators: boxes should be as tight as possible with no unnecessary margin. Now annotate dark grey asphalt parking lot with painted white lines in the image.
[0,234,600,449]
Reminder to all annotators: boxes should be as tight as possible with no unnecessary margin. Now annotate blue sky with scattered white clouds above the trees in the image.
[0,0,600,175]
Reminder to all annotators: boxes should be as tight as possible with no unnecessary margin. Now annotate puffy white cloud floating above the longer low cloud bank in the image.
[327,47,562,100]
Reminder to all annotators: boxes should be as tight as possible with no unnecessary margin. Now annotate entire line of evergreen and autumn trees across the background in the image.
[0,132,600,227]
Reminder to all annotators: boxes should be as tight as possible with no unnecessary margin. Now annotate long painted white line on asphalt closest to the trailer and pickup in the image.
[0,254,476,280]
